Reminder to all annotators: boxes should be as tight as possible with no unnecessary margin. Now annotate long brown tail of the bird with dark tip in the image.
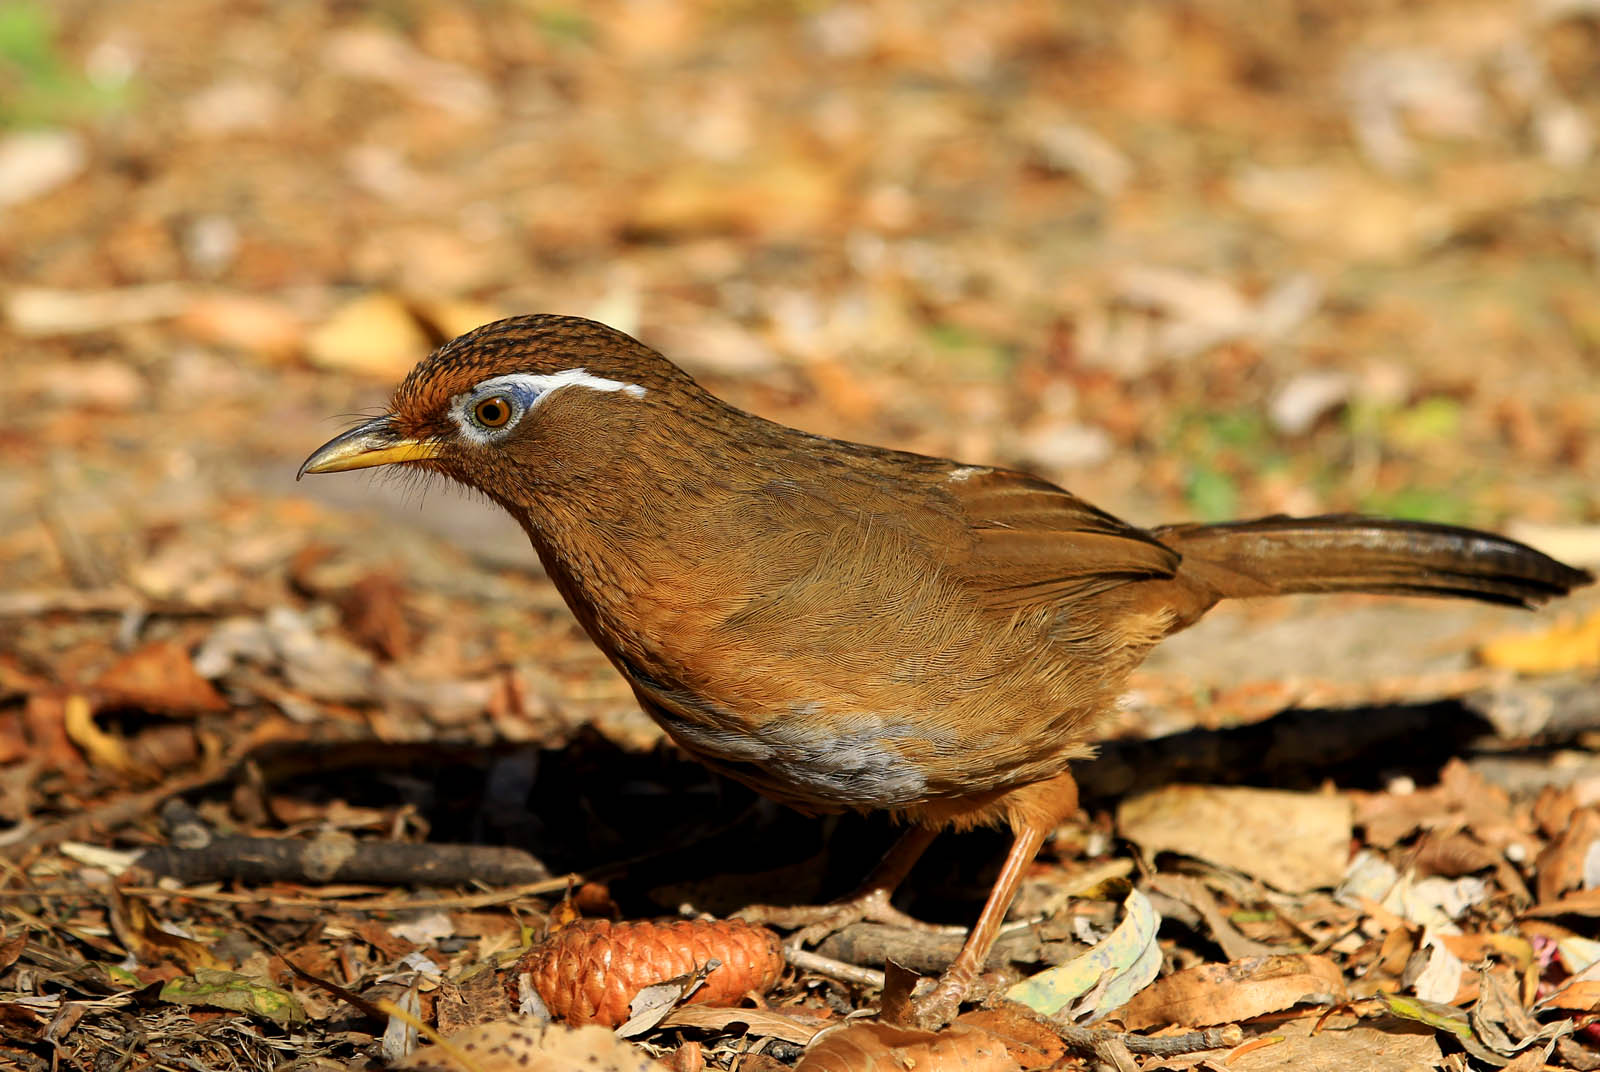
[1154,514,1595,606]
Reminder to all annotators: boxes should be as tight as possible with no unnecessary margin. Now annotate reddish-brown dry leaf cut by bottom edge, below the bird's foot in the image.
[795,1021,1021,1072]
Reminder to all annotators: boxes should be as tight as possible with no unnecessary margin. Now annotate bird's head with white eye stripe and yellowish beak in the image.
[299,315,701,501]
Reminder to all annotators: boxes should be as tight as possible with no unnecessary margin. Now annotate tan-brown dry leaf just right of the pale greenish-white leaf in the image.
[1117,955,1349,1030]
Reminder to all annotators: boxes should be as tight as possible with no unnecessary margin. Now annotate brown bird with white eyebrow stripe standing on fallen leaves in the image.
[301,315,1594,1019]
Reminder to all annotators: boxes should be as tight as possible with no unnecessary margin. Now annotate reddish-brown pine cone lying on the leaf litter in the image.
[507,920,784,1027]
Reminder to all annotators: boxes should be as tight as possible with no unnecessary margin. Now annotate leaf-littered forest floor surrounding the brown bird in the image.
[0,0,1600,1072]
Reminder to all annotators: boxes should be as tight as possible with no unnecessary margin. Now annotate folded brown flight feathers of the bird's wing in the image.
[941,469,1181,610]
